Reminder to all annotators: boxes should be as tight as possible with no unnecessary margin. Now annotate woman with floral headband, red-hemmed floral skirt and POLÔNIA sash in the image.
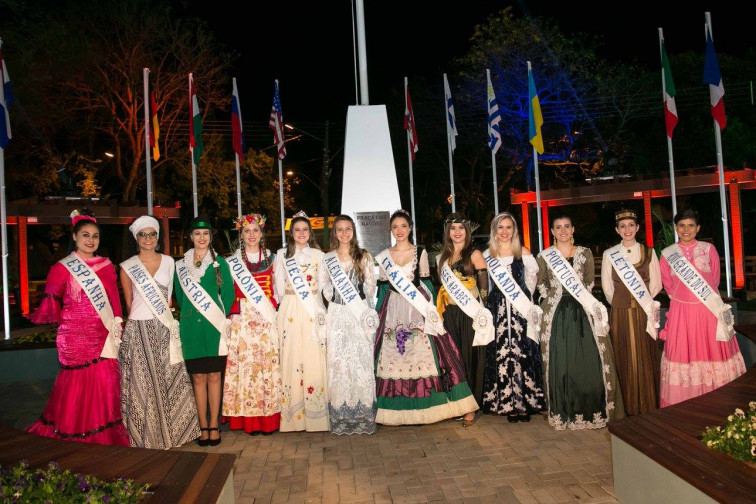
[223,213,281,436]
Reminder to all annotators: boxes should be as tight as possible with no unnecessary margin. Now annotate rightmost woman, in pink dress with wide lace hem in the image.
[659,209,746,408]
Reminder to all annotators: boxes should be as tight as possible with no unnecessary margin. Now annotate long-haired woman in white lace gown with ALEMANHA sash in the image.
[323,215,376,434]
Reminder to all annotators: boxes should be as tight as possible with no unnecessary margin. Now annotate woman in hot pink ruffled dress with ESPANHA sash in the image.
[27,210,129,446]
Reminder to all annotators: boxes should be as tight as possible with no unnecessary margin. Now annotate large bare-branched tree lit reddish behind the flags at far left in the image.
[4,0,233,201]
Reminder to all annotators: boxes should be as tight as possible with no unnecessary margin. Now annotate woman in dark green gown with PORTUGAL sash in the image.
[537,215,624,430]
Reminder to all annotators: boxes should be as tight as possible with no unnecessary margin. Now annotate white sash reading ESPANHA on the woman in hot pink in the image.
[58,252,123,359]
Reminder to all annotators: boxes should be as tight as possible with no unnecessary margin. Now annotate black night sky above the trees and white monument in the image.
[189,0,755,136]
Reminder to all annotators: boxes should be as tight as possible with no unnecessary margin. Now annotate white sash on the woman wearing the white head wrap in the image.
[121,256,184,364]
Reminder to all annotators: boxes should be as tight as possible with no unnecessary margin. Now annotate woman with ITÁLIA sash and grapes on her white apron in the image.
[374,210,478,425]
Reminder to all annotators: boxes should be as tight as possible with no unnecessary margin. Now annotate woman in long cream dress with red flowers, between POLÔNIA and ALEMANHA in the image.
[273,212,328,432]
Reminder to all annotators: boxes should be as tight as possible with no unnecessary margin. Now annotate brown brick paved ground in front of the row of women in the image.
[0,381,617,504]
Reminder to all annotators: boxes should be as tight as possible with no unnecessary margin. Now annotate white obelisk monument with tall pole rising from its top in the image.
[341,0,402,254]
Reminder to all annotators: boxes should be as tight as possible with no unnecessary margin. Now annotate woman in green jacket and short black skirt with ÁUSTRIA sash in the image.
[173,217,236,446]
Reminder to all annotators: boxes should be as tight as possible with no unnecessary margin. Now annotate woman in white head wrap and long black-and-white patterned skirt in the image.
[118,215,200,449]
